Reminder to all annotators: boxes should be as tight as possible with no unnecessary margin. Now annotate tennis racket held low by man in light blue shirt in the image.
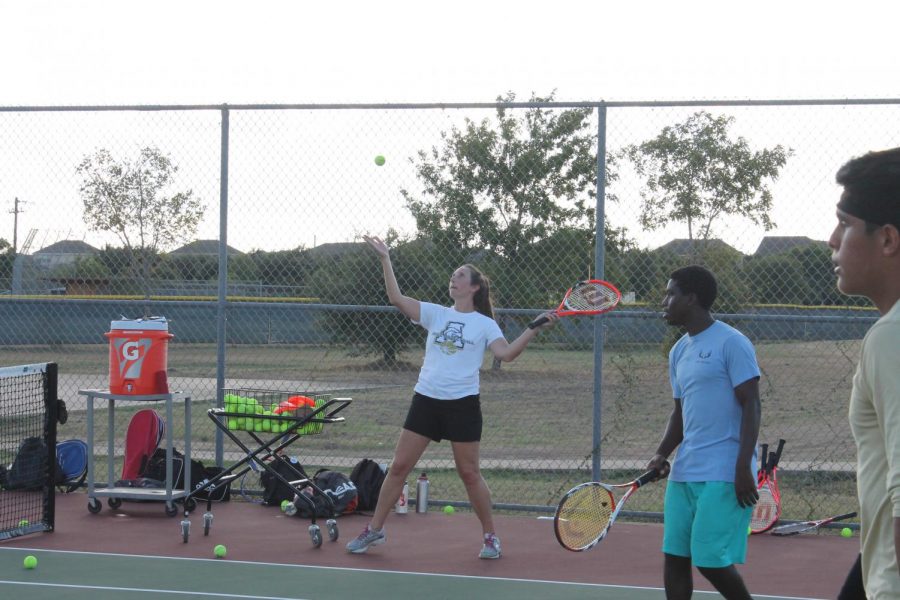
[553,470,660,552]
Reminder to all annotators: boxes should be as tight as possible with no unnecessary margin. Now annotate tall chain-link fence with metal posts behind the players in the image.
[0,97,900,519]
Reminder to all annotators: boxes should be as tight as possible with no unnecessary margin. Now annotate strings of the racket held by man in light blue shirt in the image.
[557,485,615,548]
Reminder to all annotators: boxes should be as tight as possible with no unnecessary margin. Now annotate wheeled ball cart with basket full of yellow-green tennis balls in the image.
[181,388,352,548]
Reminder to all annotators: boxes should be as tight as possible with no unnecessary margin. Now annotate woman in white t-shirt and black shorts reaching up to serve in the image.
[347,236,559,559]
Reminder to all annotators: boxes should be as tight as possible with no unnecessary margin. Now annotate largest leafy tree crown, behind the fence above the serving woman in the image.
[401,93,620,306]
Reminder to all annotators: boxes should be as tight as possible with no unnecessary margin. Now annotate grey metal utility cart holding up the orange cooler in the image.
[78,389,196,517]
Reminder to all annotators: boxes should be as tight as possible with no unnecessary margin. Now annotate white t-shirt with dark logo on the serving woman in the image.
[415,302,503,400]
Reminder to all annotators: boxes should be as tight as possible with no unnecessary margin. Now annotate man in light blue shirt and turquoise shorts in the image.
[648,266,760,600]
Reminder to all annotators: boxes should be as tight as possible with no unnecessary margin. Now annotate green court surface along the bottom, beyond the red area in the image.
[0,548,824,600]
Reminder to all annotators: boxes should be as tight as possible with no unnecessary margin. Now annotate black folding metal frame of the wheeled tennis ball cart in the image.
[181,389,352,548]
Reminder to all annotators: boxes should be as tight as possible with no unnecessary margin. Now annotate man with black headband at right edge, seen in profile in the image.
[828,148,900,600]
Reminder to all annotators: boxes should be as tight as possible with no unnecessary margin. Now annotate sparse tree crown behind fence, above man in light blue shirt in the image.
[622,111,792,239]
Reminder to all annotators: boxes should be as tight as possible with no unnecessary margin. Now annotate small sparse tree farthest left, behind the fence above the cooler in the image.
[77,148,205,296]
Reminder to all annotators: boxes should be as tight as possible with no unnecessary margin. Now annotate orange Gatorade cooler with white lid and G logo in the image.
[104,317,174,396]
